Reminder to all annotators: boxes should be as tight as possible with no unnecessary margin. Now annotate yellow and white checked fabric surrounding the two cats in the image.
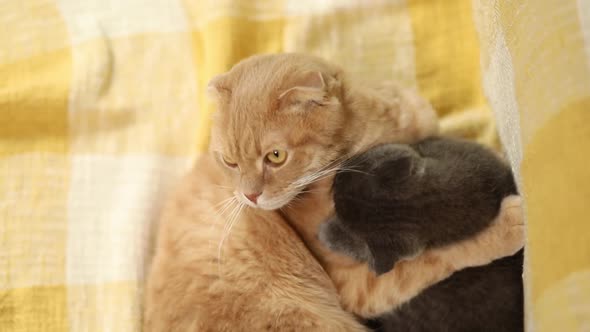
[0,0,590,332]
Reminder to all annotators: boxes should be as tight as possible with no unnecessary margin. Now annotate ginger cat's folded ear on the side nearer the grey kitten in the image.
[279,71,339,107]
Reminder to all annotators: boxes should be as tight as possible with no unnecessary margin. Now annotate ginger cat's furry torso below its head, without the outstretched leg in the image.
[144,155,364,332]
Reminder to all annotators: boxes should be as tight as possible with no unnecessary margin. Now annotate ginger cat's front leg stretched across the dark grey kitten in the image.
[332,196,524,318]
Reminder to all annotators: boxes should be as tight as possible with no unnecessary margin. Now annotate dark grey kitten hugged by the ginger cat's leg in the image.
[320,138,523,332]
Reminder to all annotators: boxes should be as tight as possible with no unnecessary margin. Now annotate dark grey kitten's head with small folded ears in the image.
[326,144,426,275]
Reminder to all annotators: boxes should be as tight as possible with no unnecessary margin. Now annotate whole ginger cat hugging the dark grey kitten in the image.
[145,54,523,331]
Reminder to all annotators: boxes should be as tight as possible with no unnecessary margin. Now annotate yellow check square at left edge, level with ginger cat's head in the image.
[0,49,72,155]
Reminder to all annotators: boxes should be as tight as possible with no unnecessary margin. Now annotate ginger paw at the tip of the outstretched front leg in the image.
[494,195,525,257]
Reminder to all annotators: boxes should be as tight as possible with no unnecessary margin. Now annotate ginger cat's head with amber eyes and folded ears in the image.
[208,54,346,210]
